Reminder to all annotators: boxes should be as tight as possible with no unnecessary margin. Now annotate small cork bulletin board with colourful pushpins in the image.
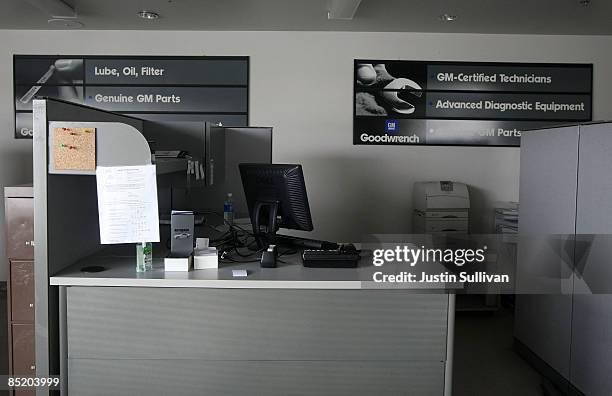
[53,127,96,171]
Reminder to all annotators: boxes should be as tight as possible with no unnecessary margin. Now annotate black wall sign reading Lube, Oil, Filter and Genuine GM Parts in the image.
[13,55,249,139]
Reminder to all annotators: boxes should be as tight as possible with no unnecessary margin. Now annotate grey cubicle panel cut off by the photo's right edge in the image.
[571,123,612,396]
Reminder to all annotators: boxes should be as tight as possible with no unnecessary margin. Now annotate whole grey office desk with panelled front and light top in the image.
[50,251,454,395]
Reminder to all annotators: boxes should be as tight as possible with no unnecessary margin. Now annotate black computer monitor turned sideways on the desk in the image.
[239,164,313,245]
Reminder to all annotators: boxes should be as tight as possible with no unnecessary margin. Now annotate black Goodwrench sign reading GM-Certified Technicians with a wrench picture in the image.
[353,60,593,146]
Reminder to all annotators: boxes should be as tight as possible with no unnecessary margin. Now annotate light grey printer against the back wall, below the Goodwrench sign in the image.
[412,181,470,234]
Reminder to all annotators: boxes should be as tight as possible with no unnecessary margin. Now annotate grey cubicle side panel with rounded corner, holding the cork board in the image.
[33,99,151,390]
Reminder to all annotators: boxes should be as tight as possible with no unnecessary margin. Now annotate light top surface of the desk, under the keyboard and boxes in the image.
[50,251,461,292]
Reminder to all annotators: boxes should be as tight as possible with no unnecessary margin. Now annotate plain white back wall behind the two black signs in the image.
[0,30,612,279]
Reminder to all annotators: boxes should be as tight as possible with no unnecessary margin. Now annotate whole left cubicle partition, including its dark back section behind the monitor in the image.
[33,99,272,390]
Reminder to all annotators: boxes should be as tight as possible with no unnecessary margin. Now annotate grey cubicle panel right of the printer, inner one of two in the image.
[514,126,578,384]
